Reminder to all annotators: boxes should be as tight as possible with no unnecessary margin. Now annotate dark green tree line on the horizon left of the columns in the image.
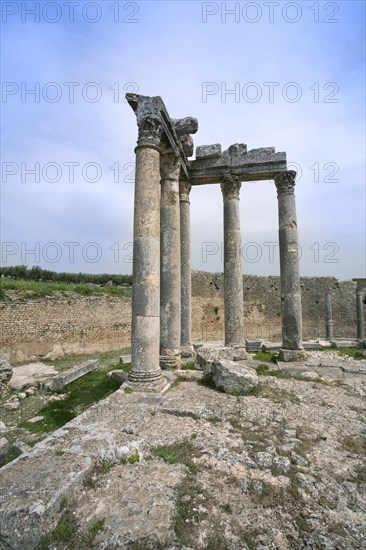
[0,265,132,286]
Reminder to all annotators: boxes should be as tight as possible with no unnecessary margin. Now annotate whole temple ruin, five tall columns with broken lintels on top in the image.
[126,94,304,391]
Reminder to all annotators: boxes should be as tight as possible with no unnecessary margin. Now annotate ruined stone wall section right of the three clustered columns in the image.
[192,271,356,340]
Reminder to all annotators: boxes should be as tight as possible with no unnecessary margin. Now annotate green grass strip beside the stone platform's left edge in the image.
[20,370,120,433]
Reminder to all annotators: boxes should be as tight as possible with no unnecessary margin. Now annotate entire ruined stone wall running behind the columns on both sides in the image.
[0,271,360,362]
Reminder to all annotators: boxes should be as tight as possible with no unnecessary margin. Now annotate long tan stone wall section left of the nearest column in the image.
[0,295,131,362]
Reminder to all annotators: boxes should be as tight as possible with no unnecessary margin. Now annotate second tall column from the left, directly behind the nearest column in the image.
[160,152,180,369]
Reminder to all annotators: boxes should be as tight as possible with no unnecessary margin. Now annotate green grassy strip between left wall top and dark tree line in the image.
[0,278,132,300]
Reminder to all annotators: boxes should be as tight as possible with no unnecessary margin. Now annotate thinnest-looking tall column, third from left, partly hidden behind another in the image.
[179,180,192,352]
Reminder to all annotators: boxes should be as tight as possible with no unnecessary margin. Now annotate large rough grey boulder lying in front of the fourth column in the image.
[212,360,258,394]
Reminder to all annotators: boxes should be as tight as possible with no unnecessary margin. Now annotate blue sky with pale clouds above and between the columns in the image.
[1,0,366,279]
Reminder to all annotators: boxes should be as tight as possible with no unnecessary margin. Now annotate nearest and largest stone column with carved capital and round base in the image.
[127,116,166,391]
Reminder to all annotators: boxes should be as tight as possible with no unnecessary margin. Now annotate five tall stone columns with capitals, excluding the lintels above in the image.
[129,115,303,391]
